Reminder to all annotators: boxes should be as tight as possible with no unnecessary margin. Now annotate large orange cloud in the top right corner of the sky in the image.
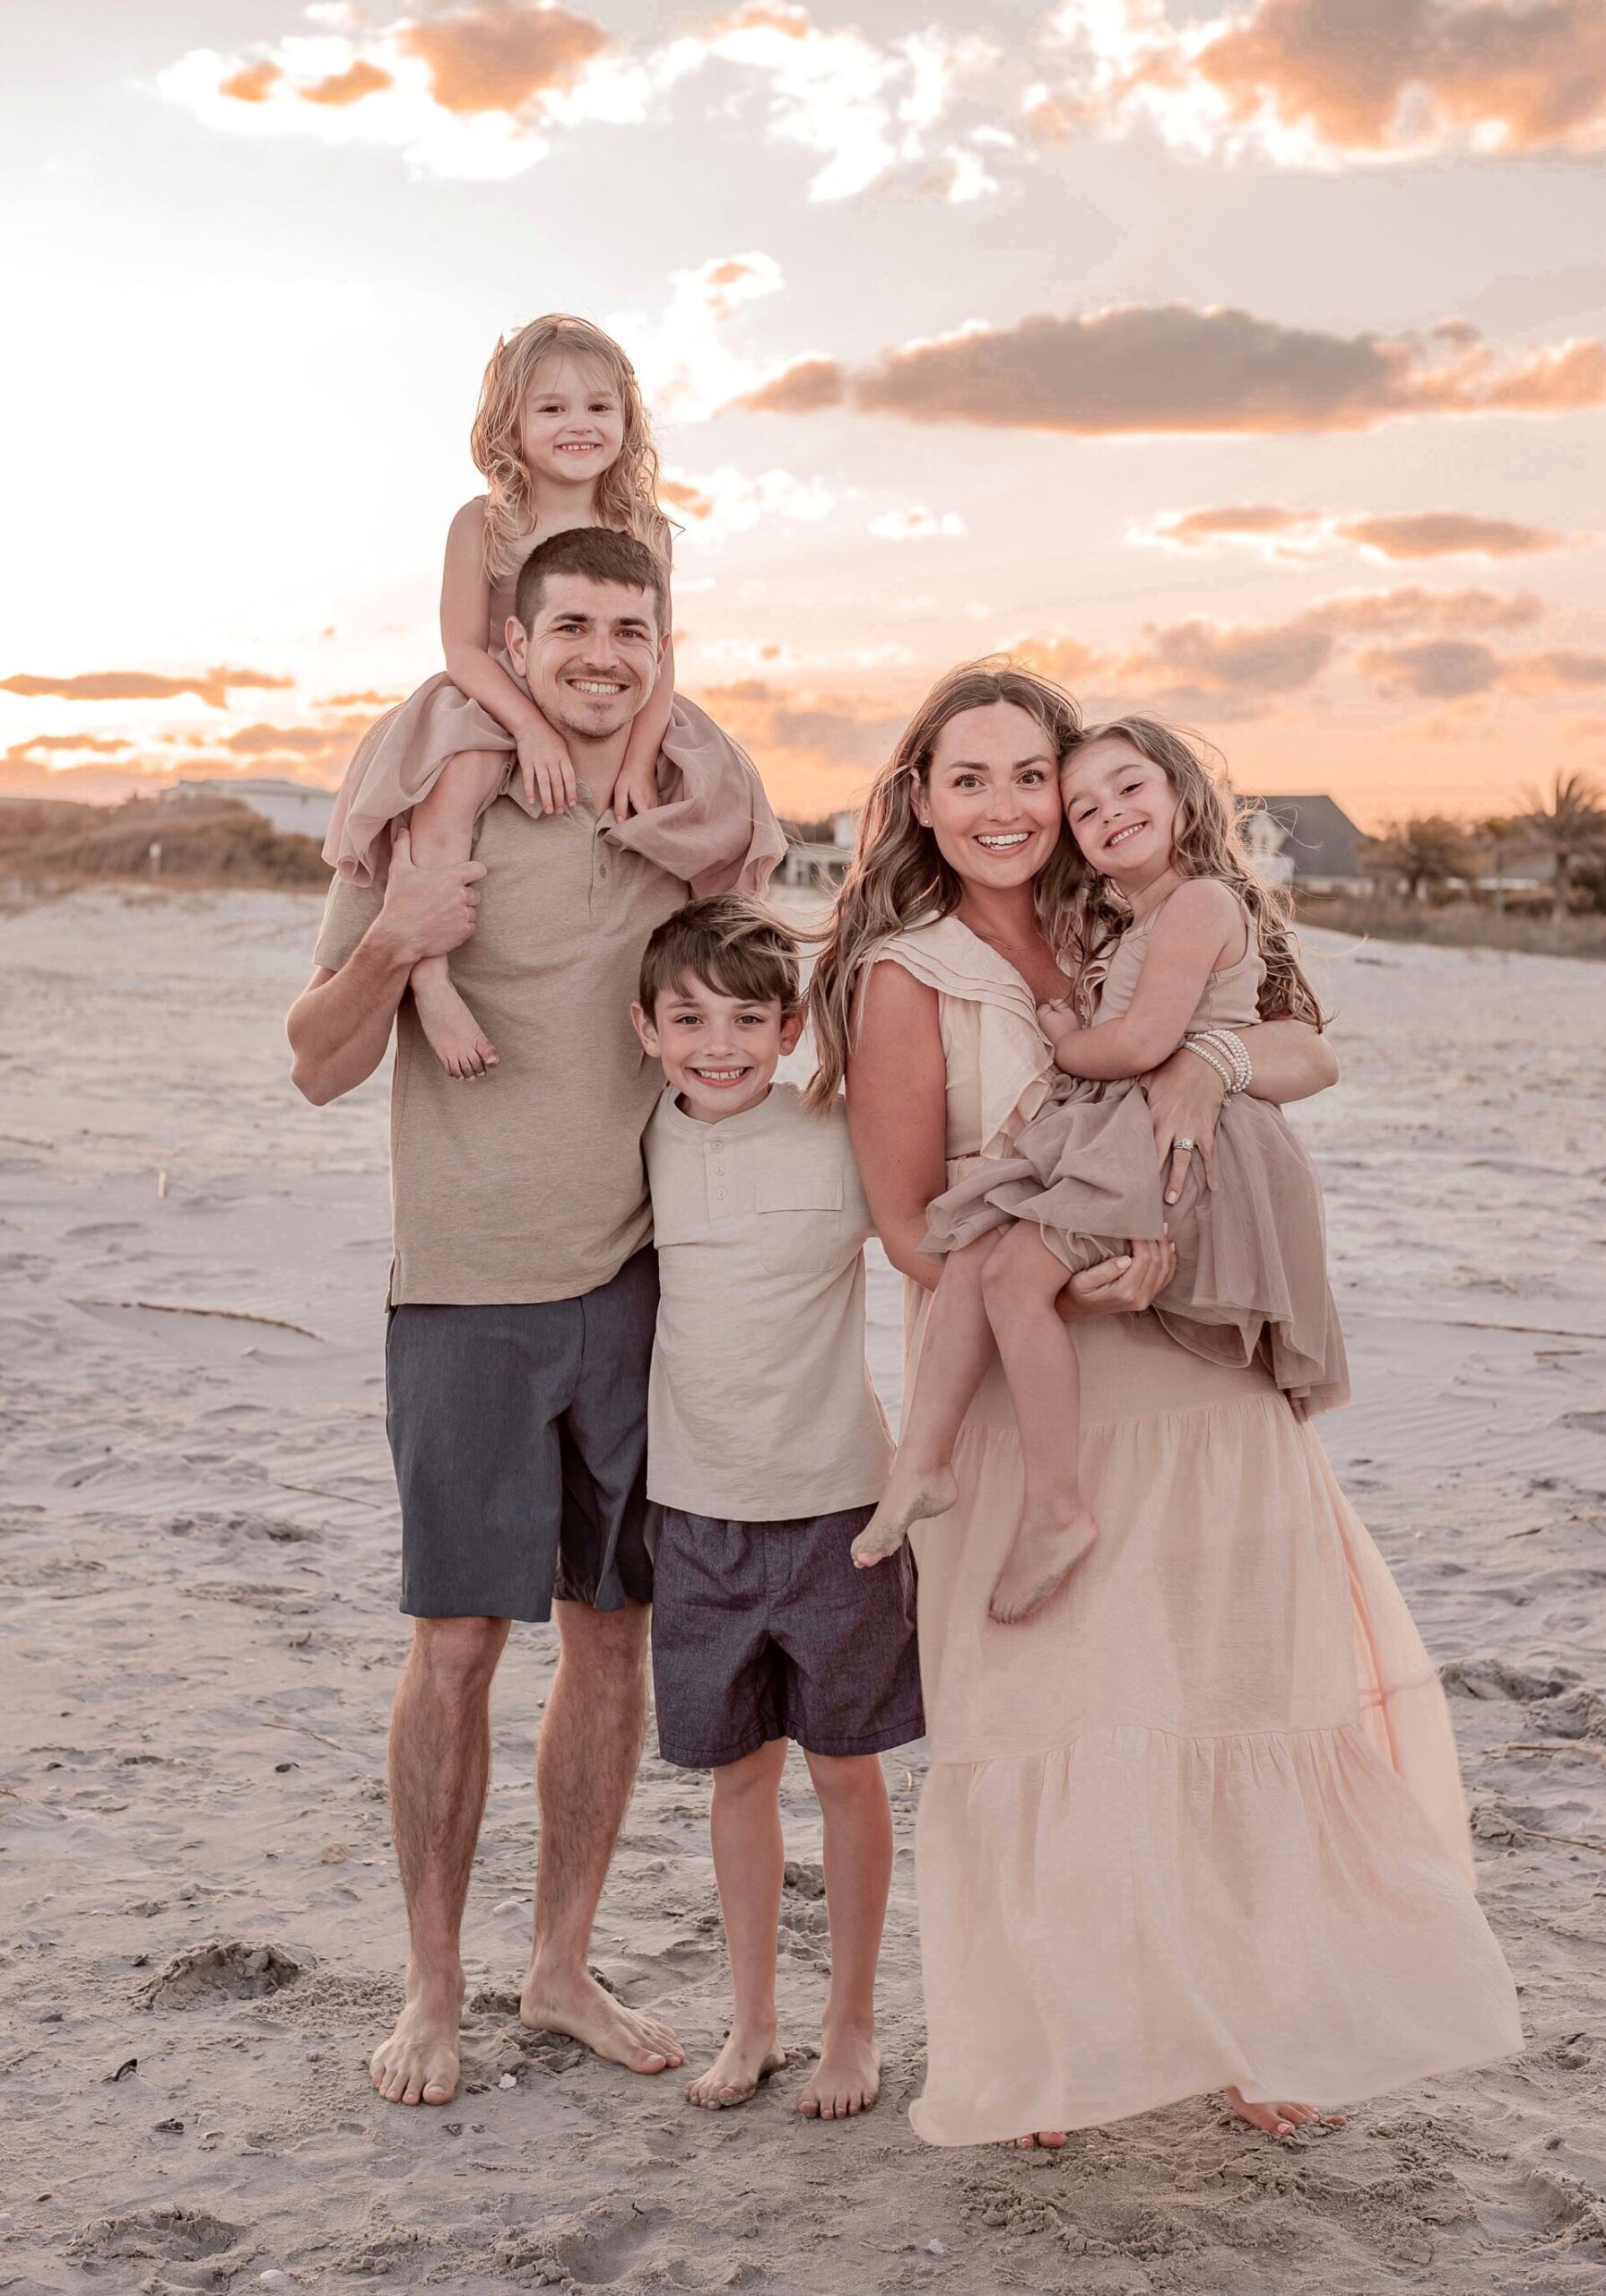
[1170,0,1606,152]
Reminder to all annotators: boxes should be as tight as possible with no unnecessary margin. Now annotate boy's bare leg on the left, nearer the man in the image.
[686,1738,787,2112]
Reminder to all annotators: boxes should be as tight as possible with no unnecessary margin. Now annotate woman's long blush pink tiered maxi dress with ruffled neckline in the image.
[879,918,1524,2144]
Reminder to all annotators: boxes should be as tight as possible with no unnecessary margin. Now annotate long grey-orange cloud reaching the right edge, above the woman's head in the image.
[739,303,1606,436]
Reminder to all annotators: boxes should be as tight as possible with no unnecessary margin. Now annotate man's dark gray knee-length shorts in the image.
[386,1247,658,1619]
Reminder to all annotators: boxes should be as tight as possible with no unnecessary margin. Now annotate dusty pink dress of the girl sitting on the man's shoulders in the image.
[324,560,787,900]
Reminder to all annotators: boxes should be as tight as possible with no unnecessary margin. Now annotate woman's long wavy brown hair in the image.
[803,661,1085,1109]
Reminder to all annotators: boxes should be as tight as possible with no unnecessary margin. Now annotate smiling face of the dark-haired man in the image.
[507,574,663,742]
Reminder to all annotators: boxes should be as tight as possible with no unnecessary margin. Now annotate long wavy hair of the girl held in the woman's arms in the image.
[1072,717,1326,1029]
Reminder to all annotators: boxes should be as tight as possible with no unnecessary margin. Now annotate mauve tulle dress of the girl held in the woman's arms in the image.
[923,902,1349,1412]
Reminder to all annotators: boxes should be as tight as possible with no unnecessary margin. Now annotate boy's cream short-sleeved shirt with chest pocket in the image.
[647,1083,892,1522]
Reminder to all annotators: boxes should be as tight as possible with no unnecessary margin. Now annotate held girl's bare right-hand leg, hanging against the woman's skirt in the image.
[982,1219,1099,1625]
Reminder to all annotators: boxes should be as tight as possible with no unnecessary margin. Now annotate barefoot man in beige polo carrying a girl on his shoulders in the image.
[289,528,773,2106]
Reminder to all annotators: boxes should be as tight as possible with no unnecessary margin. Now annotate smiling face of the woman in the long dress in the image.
[916,702,1064,891]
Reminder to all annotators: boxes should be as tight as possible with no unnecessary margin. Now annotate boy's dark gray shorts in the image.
[652,1506,925,1770]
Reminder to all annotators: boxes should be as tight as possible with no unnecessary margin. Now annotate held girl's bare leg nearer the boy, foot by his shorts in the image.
[854,1235,998,1570]
